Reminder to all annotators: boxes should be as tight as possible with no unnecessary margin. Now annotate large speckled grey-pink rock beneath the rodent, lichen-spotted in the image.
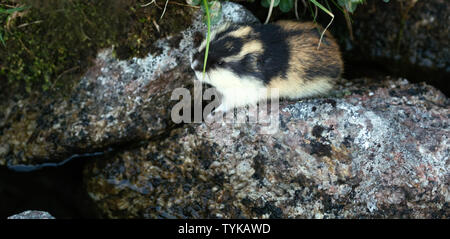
[85,80,450,218]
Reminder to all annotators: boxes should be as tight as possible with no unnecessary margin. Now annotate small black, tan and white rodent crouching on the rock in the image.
[191,21,343,112]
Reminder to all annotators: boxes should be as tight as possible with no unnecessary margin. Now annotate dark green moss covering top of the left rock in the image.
[0,0,193,96]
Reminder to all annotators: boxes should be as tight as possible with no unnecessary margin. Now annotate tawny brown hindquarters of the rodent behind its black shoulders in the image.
[268,21,343,98]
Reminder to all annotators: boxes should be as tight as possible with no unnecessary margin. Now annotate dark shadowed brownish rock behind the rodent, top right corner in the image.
[353,0,450,70]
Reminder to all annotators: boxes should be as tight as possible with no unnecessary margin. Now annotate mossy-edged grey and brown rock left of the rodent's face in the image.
[0,3,257,171]
